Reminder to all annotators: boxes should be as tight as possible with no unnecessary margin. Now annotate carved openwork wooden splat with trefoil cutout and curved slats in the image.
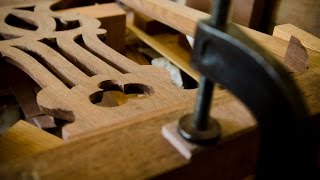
[0,1,194,138]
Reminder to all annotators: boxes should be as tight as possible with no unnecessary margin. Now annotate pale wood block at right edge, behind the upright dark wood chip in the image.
[272,24,320,52]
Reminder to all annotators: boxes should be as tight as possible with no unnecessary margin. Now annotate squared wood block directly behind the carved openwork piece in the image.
[59,3,126,53]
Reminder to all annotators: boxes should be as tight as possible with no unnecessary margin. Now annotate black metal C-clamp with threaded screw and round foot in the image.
[178,0,316,179]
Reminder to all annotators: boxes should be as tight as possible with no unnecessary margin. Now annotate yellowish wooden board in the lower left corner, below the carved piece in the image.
[0,120,63,165]
